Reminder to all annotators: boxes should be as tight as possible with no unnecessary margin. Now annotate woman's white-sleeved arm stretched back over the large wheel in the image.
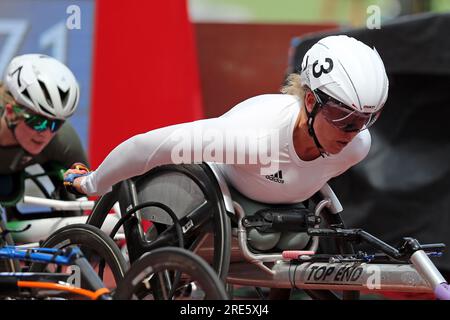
[74,118,255,195]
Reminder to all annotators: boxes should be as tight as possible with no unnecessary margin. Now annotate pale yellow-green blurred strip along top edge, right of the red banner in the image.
[188,0,450,27]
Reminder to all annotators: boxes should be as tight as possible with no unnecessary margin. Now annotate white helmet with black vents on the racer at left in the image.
[4,54,80,119]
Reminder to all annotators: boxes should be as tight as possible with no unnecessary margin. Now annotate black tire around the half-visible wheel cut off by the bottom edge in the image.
[114,247,228,300]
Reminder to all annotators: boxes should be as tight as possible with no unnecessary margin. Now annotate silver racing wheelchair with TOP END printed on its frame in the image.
[81,163,450,299]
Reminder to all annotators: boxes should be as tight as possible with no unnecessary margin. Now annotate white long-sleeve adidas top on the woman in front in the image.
[81,94,371,203]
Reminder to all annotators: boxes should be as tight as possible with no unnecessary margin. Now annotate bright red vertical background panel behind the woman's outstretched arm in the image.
[89,0,203,168]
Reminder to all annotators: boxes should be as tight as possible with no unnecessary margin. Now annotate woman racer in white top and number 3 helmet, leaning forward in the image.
[65,36,450,300]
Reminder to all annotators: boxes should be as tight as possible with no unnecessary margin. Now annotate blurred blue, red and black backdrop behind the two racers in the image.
[0,0,450,296]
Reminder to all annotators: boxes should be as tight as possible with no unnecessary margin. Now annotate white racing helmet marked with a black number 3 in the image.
[300,35,389,113]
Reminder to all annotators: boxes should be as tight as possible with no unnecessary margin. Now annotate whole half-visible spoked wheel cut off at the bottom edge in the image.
[114,247,228,300]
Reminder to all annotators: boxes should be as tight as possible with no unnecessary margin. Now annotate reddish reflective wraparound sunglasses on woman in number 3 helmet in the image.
[313,90,382,132]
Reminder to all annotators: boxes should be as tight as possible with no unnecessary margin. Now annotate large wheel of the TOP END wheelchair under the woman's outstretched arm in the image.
[87,164,231,281]
